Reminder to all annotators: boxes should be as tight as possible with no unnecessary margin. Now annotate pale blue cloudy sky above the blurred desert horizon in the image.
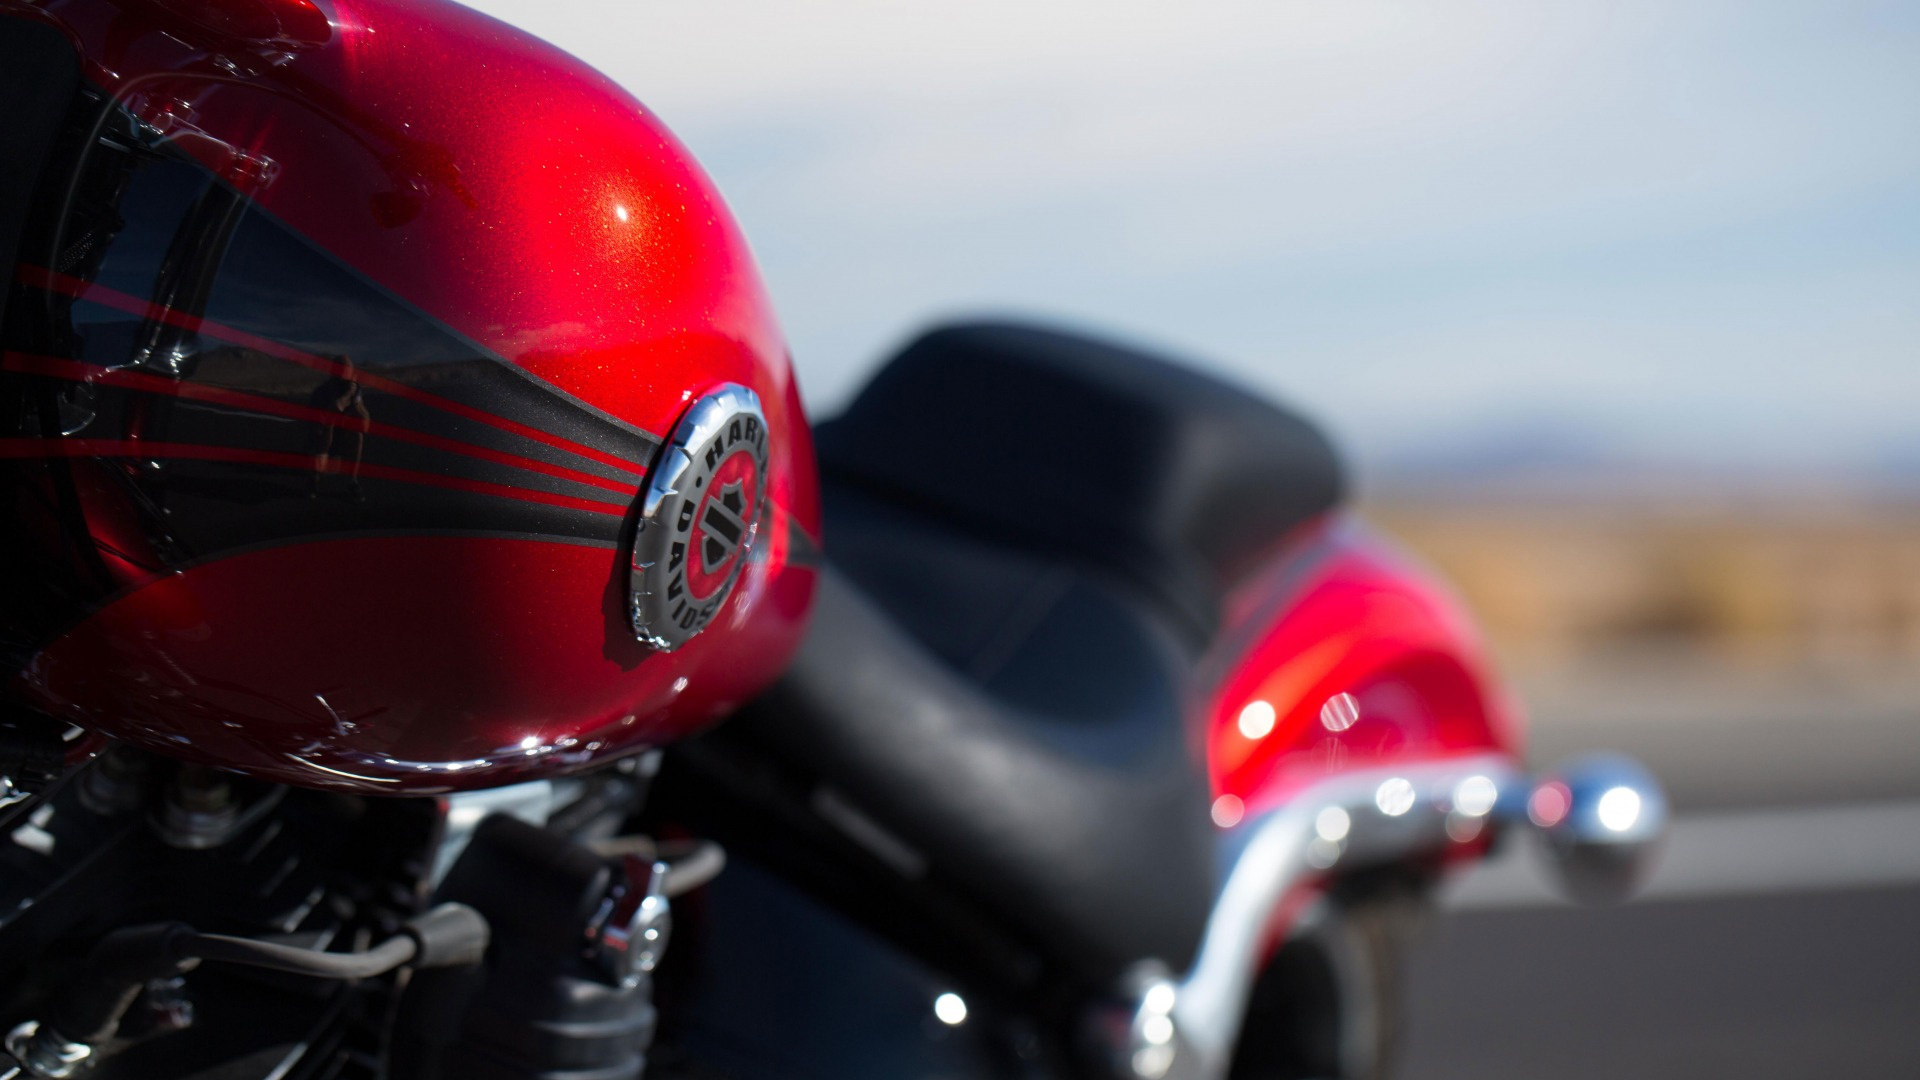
[456,0,1920,477]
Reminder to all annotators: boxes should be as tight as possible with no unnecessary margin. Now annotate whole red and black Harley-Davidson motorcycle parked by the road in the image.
[0,0,1665,1080]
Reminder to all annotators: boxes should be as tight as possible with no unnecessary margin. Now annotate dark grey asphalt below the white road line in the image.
[1400,886,1920,1080]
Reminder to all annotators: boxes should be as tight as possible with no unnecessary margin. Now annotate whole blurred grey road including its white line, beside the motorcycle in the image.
[1400,668,1920,1080]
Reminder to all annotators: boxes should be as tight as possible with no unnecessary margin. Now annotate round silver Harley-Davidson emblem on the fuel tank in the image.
[632,382,766,651]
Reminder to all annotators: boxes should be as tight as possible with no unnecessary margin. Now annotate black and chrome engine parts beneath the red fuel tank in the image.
[0,730,691,1080]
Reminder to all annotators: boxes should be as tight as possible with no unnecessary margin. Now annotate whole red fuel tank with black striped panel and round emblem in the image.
[0,0,820,794]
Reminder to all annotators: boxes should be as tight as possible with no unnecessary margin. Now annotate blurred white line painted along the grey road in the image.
[1440,801,1920,909]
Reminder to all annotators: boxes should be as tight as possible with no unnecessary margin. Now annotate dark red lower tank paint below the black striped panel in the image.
[27,536,810,794]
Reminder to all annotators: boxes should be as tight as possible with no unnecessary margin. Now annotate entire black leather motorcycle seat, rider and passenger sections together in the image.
[747,317,1340,978]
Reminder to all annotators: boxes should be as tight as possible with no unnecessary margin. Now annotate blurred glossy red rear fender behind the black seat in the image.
[1206,521,1523,815]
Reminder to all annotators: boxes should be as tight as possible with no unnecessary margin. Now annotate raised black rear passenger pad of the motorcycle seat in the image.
[816,323,1344,638]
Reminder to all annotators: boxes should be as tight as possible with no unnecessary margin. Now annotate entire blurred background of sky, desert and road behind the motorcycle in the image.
[478,0,1920,1080]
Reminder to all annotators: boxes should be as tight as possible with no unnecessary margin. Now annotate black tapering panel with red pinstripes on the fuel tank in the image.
[0,77,655,667]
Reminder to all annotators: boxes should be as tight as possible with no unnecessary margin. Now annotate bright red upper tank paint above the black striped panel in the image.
[0,0,791,434]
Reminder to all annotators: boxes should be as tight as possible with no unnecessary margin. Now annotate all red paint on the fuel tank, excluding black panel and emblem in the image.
[0,0,820,794]
